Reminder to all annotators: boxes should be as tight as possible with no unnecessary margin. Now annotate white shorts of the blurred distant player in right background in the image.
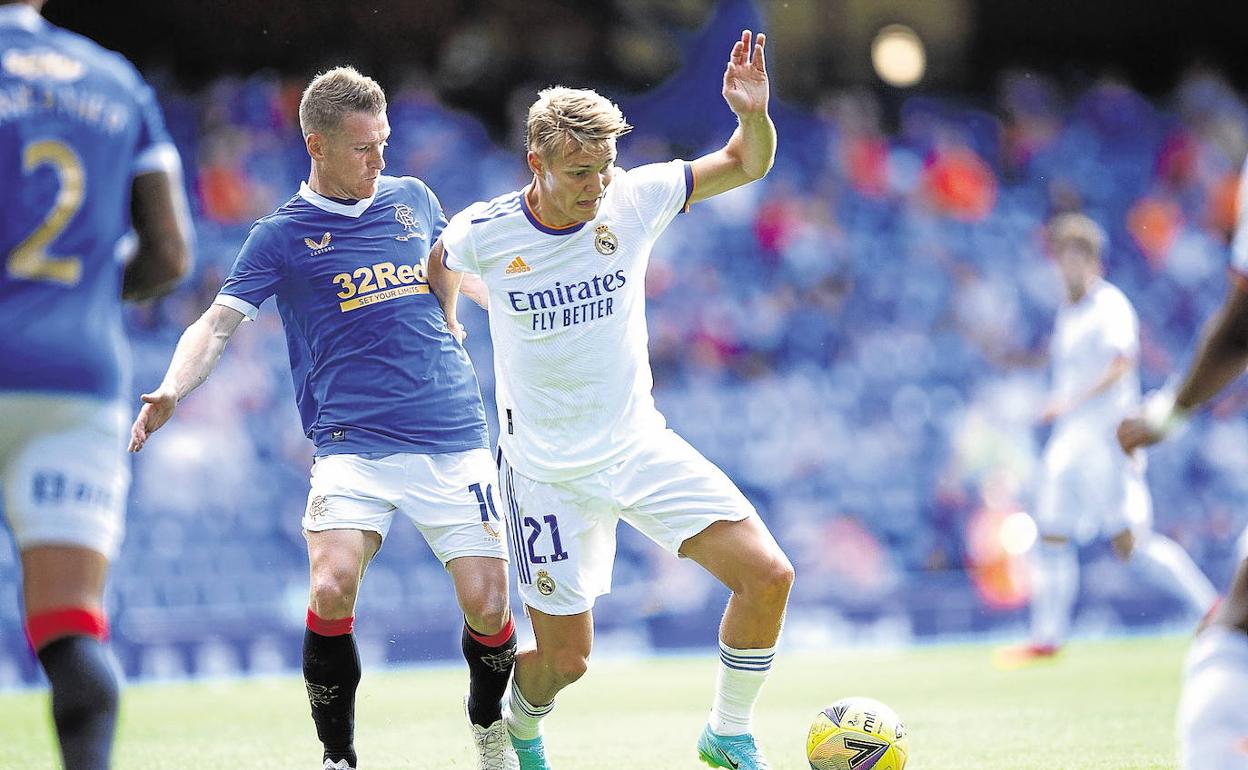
[1036,427,1153,543]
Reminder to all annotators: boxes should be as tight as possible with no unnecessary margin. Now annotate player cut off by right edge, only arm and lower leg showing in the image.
[1118,159,1248,770]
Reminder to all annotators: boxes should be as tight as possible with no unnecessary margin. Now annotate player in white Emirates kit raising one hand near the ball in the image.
[429,31,794,770]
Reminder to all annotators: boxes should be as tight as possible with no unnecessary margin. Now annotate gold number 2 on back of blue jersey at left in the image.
[5,139,86,286]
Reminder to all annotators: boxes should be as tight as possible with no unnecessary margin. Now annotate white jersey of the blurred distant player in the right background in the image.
[1051,278,1139,431]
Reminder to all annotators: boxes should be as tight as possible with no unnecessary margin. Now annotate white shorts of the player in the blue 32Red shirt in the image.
[303,448,507,564]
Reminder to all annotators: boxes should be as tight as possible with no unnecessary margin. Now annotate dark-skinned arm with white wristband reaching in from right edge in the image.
[1118,277,1248,452]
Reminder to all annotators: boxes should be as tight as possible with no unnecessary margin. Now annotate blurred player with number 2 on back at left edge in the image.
[0,0,191,770]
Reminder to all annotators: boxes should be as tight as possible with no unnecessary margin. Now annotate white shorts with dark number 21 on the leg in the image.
[499,431,758,615]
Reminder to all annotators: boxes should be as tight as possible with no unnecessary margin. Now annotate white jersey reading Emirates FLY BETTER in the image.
[442,160,694,482]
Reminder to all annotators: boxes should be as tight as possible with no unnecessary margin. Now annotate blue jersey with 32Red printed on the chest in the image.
[216,176,488,456]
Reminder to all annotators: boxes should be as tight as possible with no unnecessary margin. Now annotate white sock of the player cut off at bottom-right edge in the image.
[1178,625,1248,770]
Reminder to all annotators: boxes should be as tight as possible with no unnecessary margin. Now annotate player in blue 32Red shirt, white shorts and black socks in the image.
[130,67,515,770]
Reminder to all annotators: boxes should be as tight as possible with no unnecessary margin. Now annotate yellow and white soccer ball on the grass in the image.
[806,698,907,770]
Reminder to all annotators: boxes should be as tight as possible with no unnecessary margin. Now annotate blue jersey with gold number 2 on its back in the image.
[0,4,178,398]
